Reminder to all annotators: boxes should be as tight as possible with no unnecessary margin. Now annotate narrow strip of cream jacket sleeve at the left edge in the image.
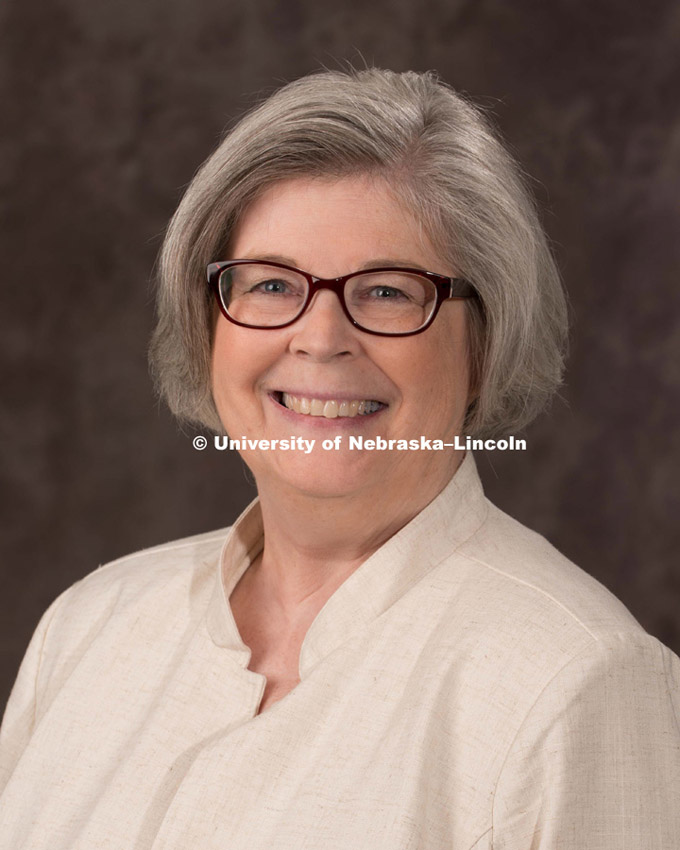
[0,594,64,795]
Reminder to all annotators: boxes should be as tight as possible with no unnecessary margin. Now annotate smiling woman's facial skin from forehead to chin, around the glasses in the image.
[212,177,468,497]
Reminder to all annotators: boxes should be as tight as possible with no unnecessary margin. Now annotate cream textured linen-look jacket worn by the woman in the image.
[0,455,680,850]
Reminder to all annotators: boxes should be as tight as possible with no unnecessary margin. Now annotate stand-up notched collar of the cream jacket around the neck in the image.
[207,452,488,679]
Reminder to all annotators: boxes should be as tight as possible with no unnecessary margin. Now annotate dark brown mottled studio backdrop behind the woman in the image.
[0,0,680,706]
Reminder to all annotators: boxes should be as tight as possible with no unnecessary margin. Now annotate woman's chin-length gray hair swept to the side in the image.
[150,68,567,436]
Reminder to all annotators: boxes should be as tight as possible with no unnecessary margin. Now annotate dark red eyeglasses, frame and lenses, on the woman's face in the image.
[207,260,476,336]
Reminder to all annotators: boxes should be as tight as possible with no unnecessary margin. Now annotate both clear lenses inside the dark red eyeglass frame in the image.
[219,263,437,333]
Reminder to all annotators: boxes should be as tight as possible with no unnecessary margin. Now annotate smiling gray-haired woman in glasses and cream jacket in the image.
[0,70,680,850]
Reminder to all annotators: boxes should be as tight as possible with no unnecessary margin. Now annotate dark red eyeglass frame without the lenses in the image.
[207,260,477,336]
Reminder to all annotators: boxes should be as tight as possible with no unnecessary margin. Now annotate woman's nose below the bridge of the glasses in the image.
[290,289,360,360]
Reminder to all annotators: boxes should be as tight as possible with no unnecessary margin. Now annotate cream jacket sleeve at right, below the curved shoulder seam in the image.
[492,633,680,850]
